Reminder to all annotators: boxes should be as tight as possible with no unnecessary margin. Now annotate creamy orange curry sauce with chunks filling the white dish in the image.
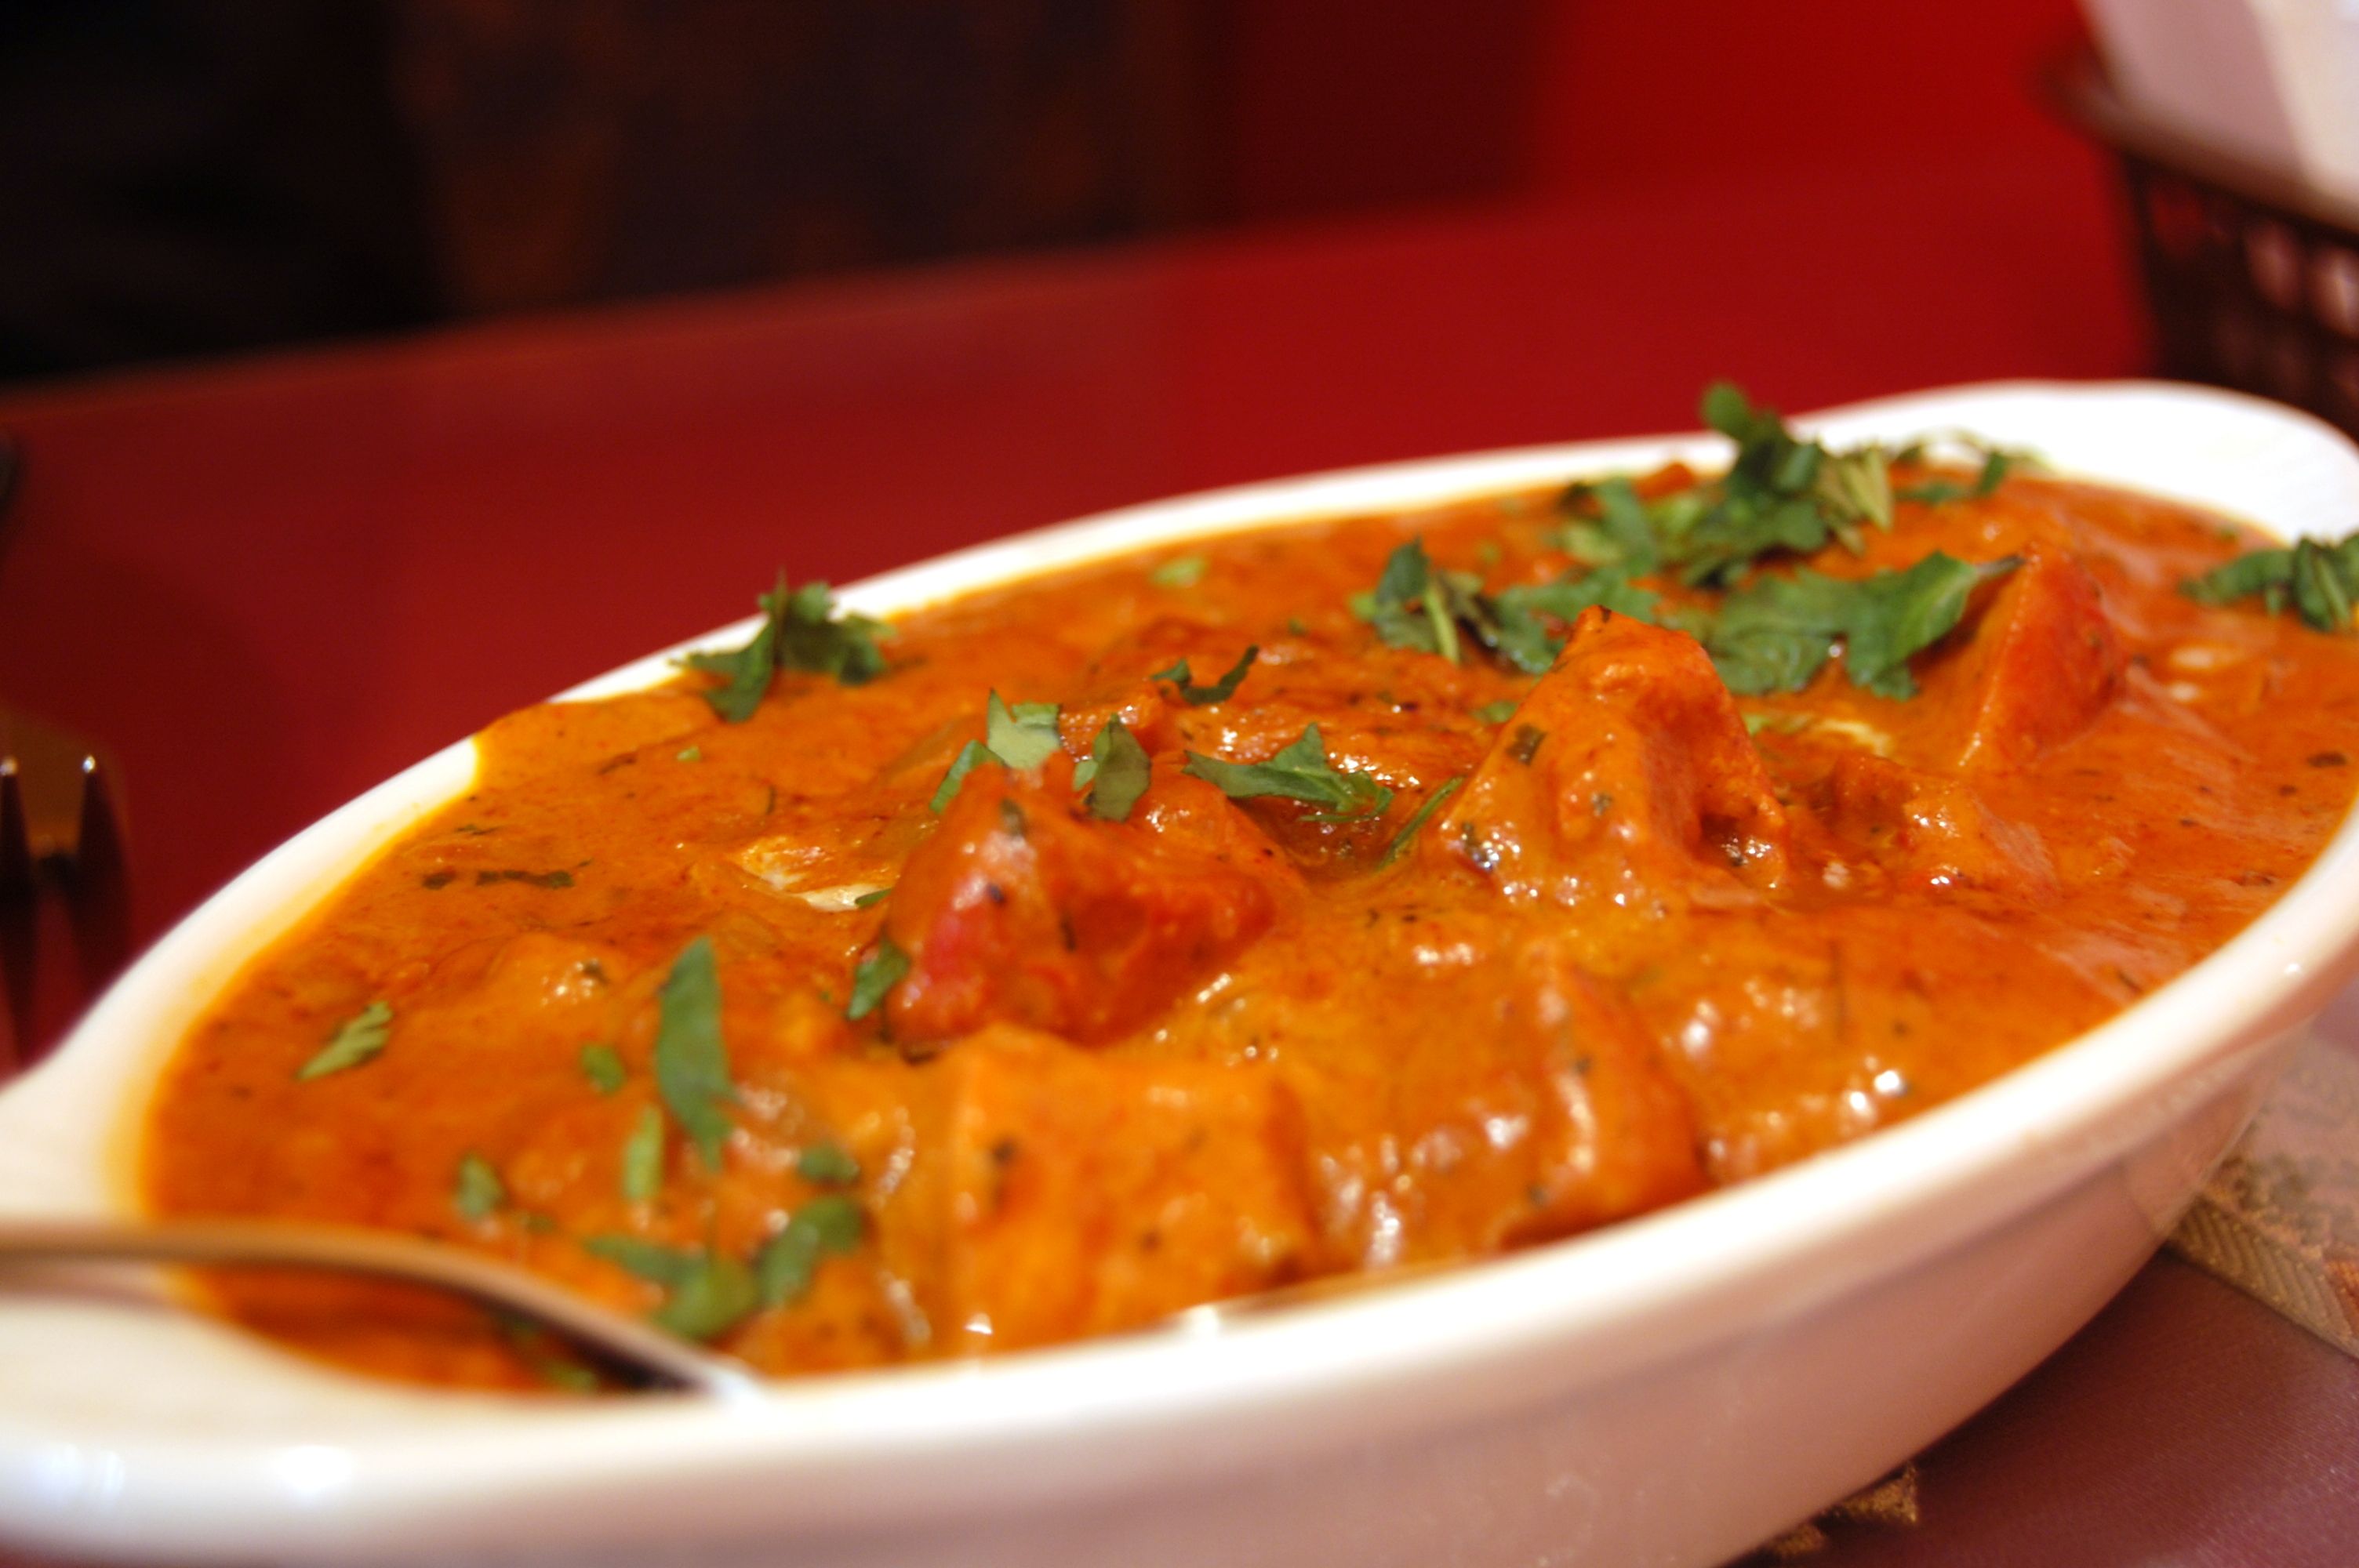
[144,464,2359,1384]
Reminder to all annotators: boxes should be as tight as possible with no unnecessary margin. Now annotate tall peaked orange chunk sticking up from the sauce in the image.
[1425,608,1788,910]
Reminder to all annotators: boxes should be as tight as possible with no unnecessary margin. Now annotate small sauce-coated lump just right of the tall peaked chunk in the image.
[1828,752,2057,898]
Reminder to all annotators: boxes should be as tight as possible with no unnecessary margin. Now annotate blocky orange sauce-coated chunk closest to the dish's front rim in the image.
[880,1025,1314,1353]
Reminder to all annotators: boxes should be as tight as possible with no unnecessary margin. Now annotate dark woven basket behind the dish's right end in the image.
[2043,49,2359,436]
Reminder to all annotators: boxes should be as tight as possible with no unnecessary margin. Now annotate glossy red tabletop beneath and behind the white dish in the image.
[0,139,2359,1563]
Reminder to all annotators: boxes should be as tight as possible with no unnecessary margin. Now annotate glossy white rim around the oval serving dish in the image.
[0,384,2359,1549]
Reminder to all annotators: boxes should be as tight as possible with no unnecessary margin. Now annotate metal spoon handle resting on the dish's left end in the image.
[0,1219,762,1400]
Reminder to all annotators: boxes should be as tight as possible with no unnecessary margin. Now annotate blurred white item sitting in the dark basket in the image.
[2083,0,2359,203]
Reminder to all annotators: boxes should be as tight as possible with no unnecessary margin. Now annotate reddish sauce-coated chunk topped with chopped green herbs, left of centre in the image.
[885,757,1274,1042]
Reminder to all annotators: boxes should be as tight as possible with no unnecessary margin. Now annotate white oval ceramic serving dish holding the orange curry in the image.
[0,384,2359,1568]
